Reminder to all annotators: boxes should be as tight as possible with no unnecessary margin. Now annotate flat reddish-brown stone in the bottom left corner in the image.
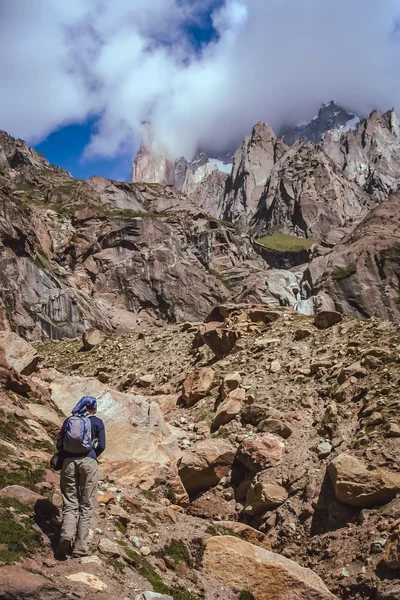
[0,565,59,600]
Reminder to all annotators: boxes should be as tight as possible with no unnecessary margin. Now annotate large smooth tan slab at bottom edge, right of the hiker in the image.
[203,536,335,600]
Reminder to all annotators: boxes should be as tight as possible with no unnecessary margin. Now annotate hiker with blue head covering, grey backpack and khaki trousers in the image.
[56,396,106,560]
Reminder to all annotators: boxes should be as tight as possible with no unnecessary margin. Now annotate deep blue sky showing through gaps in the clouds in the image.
[34,0,223,181]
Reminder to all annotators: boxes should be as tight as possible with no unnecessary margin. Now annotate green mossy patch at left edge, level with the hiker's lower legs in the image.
[0,499,42,564]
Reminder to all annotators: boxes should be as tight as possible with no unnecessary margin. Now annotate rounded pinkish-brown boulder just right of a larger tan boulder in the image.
[236,433,285,473]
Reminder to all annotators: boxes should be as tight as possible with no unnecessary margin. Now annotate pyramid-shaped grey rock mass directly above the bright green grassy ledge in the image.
[253,142,373,240]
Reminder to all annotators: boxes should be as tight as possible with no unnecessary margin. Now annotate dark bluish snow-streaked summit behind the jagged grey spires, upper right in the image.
[280,101,360,145]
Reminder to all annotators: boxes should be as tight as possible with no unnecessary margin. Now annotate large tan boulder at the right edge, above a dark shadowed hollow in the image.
[328,453,400,508]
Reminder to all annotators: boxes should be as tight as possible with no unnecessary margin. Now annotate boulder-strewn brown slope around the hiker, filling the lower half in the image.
[0,305,400,600]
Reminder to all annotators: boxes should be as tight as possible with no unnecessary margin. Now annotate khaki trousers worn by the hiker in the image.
[60,457,98,553]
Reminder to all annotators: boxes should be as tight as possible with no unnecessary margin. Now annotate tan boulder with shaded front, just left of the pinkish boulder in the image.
[178,439,235,496]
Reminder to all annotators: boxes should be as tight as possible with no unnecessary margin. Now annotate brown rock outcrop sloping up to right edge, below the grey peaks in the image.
[304,194,400,322]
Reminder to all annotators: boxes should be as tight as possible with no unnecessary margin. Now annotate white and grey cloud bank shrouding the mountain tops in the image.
[0,0,400,164]
